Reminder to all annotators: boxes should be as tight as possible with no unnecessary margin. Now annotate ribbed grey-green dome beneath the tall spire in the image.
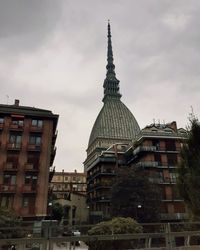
[88,98,140,146]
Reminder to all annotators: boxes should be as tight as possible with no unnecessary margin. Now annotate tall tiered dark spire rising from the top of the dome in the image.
[103,20,121,102]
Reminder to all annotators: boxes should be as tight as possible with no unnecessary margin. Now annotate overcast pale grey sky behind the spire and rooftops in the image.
[0,0,200,171]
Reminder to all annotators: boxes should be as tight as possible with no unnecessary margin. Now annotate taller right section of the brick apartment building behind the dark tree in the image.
[126,122,187,221]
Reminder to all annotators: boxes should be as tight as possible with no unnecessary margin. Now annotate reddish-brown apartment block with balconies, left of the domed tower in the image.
[0,100,58,218]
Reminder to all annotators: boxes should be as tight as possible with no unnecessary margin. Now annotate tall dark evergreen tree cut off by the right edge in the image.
[178,117,200,219]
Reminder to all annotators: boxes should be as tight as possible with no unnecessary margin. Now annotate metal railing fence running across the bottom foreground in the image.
[0,223,200,250]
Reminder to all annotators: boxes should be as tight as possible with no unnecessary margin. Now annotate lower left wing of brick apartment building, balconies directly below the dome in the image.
[87,143,127,223]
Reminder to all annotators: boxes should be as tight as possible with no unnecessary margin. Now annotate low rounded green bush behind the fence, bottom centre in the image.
[88,217,142,250]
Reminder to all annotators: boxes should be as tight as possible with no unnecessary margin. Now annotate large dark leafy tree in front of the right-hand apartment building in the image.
[111,168,161,223]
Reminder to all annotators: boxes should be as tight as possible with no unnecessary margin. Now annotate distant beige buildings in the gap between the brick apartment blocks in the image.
[51,170,88,225]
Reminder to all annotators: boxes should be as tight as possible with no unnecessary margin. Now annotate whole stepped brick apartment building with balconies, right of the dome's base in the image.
[87,122,187,222]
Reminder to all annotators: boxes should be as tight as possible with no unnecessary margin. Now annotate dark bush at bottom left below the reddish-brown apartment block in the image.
[0,207,23,239]
